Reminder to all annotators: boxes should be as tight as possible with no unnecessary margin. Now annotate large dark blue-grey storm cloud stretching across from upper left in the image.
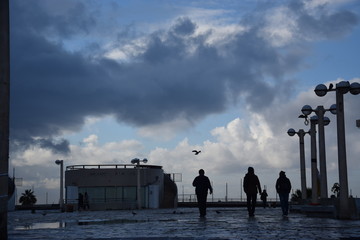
[11,1,355,152]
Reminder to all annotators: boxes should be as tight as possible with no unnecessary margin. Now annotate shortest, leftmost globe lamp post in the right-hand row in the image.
[287,128,309,200]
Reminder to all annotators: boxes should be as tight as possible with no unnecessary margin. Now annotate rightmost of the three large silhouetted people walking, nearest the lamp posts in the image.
[275,171,291,216]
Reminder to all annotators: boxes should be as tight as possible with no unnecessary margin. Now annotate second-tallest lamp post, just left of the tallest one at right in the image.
[301,104,336,199]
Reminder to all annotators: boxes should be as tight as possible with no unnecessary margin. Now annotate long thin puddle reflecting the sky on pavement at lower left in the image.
[15,219,149,230]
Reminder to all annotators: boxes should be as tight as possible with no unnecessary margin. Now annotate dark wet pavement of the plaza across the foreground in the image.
[8,208,360,240]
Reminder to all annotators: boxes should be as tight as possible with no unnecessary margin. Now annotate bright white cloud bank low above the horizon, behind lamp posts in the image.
[12,78,360,202]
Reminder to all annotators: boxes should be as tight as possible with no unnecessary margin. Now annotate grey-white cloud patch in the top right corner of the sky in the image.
[261,1,358,47]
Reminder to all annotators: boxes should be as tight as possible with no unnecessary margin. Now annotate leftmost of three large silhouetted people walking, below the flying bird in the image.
[193,169,213,217]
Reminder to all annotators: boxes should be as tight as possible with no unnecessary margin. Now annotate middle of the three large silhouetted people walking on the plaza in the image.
[243,167,261,217]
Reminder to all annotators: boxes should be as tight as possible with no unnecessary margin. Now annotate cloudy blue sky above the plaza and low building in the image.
[9,0,360,203]
